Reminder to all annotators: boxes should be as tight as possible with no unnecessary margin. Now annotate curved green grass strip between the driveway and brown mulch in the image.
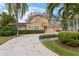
[43,41,79,56]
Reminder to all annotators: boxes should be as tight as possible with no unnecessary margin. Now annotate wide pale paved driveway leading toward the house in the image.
[0,34,57,56]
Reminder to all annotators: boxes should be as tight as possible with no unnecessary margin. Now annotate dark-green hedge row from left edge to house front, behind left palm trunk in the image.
[0,27,45,36]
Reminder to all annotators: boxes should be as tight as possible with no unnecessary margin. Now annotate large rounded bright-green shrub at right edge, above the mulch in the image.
[58,32,79,47]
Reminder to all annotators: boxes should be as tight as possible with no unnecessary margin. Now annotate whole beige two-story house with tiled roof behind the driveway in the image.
[19,14,61,32]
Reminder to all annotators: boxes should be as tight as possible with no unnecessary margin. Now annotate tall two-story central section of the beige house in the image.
[27,16,48,30]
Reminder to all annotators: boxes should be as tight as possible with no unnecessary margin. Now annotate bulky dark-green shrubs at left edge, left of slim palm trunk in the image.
[0,26,16,36]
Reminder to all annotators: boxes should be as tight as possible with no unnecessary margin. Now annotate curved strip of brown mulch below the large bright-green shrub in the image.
[54,40,79,52]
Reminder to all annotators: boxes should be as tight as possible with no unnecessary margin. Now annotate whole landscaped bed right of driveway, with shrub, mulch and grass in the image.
[42,31,79,56]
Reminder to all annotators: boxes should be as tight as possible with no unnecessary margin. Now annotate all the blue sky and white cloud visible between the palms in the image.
[0,3,63,22]
